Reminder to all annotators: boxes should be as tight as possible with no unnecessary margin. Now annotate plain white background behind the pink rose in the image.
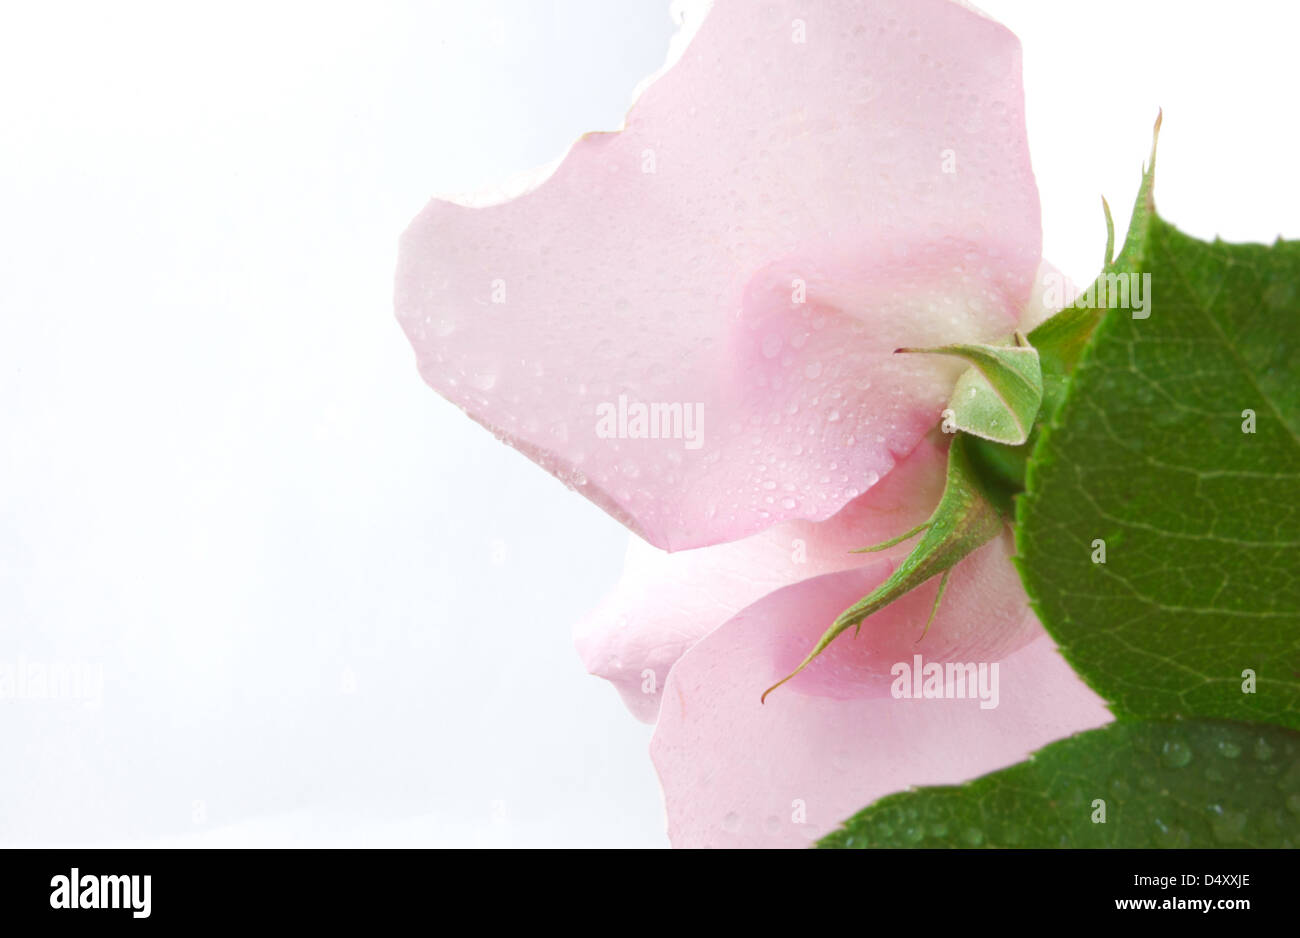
[0,0,1300,846]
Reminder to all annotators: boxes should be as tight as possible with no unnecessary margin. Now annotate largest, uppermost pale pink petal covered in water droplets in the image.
[397,0,1040,550]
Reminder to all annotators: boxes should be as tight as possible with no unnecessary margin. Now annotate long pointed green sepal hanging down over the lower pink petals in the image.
[762,434,1006,700]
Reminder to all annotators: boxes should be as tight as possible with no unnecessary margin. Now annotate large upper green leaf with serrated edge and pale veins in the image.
[1017,210,1300,728]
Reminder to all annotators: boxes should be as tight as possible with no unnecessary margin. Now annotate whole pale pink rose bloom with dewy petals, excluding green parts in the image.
[397,0,1109,846]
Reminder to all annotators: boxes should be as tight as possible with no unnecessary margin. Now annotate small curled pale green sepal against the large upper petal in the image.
[897,333,1043,446]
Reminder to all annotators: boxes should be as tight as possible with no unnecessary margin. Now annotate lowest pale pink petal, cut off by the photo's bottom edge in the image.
[651,566,1110,847]
